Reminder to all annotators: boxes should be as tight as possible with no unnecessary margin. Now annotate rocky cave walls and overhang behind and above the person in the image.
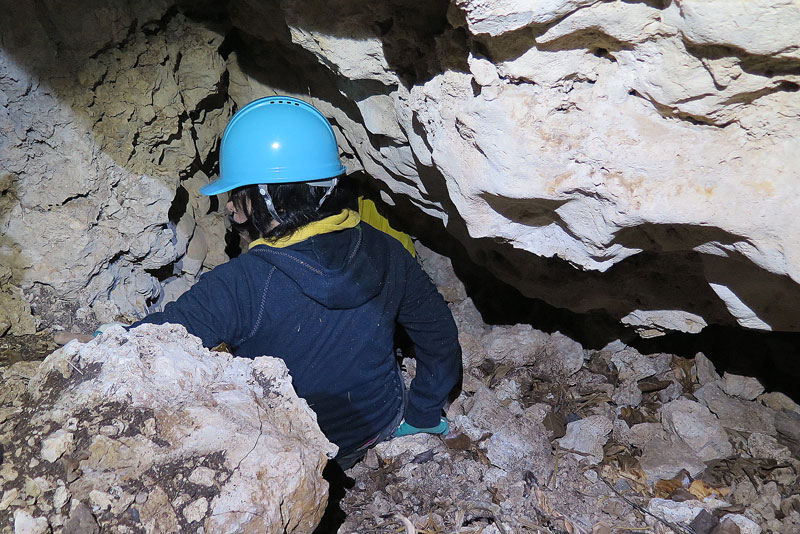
[0,0,800,336]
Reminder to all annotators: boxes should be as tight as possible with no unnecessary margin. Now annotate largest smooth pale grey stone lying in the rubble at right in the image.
[661,399,733,462]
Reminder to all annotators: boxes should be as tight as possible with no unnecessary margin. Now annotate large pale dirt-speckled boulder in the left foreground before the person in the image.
[0,325,336,534]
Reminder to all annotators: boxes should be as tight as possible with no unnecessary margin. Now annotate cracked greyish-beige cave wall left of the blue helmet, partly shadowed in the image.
[0,1,231,334]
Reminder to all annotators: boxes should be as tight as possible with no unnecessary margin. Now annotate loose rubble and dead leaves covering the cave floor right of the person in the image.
[339,247,800,534]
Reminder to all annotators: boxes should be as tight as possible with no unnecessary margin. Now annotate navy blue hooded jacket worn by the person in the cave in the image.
[142,223,461,454]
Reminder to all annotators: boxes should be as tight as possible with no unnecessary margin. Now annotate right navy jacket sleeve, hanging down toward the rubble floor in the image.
[398,254,461,428]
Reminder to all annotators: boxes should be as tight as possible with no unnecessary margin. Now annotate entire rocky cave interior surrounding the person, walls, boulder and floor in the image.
[0,0,800,534]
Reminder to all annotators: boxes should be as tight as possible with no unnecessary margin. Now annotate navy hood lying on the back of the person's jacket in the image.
[248,225,388,309]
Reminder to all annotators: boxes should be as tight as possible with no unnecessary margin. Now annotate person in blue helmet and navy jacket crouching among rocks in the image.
[129,97,461,469]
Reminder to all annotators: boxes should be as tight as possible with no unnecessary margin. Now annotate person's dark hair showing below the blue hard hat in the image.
[230,176,357,239]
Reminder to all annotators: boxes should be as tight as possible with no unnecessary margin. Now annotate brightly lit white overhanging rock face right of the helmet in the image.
[266,0,800,335]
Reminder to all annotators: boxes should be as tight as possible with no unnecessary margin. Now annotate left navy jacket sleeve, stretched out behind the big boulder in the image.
[133,264,252,348]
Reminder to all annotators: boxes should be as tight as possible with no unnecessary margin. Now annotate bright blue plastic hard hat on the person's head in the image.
[200,96,345,195]
